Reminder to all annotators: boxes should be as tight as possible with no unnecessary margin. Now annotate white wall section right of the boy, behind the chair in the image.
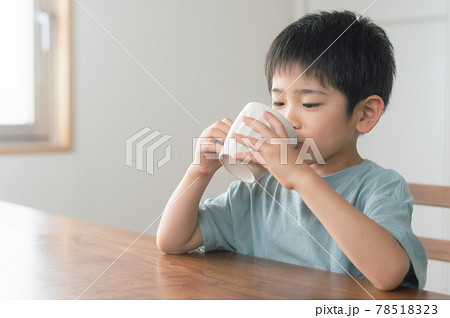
[295,0,450,293]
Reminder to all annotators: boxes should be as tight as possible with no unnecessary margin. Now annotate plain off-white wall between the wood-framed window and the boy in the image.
[0,0,293,234]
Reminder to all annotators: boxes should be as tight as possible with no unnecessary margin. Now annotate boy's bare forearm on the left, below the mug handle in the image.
[156,165,212,254]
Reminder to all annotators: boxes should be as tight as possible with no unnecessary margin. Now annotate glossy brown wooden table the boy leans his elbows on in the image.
[0,202,450,299]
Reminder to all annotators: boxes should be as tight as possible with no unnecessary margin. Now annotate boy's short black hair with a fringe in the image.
[265,11,395,118]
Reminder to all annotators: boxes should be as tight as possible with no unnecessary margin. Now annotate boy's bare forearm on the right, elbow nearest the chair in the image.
[294,165,410,290]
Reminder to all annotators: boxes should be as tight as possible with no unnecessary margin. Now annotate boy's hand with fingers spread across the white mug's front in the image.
[231,111,302,189]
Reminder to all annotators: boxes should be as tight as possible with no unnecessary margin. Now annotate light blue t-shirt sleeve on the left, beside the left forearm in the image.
[198,181,248,252]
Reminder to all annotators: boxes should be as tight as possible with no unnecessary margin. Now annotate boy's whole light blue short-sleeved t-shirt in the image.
[198,159,427,288]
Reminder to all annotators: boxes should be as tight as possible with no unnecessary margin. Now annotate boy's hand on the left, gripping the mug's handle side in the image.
[191,118,233,176]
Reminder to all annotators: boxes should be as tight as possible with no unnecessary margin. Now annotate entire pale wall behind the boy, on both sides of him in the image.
[0,0,450,293]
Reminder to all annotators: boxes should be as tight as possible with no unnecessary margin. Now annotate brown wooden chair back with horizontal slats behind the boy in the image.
[408,183,450,262]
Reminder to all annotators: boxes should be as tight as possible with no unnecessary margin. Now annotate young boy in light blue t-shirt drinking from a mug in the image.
[157,11,427,290]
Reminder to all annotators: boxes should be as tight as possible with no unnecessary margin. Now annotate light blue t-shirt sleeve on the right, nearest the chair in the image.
[364,170,427,289]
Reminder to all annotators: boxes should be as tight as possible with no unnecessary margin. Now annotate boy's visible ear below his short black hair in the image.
[355,95,384,134]
